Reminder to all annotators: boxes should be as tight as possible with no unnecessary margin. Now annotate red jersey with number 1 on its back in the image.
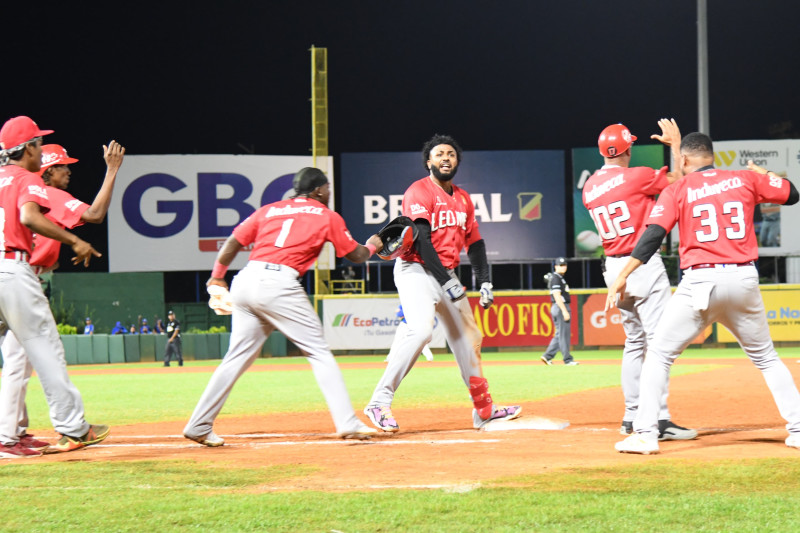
[233,197,358,276]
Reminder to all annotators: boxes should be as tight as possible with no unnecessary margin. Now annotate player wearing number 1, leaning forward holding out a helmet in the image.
[183,168,382,446]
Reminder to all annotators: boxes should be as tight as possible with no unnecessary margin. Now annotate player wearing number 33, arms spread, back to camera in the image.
[606,133,800,454]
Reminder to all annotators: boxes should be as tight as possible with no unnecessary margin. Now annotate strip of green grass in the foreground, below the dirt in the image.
[0,459,800,532]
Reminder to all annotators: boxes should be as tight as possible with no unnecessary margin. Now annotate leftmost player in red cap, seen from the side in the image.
[0,116,109,458]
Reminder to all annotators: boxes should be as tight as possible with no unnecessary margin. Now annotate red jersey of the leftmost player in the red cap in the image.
[0,165,50,254]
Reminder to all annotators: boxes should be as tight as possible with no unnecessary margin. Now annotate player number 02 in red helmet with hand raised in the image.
[583,119,697,440]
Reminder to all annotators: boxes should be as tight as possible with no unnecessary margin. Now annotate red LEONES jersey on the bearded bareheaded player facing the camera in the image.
[402,176,481,268]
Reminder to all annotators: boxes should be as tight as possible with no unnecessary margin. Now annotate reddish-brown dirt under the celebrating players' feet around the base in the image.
[23,357,800,490]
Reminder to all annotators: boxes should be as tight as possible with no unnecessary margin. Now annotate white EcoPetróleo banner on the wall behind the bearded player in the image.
[322,298,446,352]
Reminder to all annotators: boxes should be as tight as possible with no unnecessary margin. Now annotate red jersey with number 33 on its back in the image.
[647,168,789,268]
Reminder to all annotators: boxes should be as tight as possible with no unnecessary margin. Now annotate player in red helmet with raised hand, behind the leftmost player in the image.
[0,141,125,452]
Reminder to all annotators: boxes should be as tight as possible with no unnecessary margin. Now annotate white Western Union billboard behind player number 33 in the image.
[714,139,800,255]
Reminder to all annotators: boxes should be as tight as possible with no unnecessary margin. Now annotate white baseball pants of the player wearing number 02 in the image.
[603,254,672,422]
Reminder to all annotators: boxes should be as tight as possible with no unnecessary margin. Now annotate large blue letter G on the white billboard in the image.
[122,173,192,237]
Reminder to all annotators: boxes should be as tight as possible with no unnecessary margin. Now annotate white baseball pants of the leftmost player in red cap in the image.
[0,259,89,444]
